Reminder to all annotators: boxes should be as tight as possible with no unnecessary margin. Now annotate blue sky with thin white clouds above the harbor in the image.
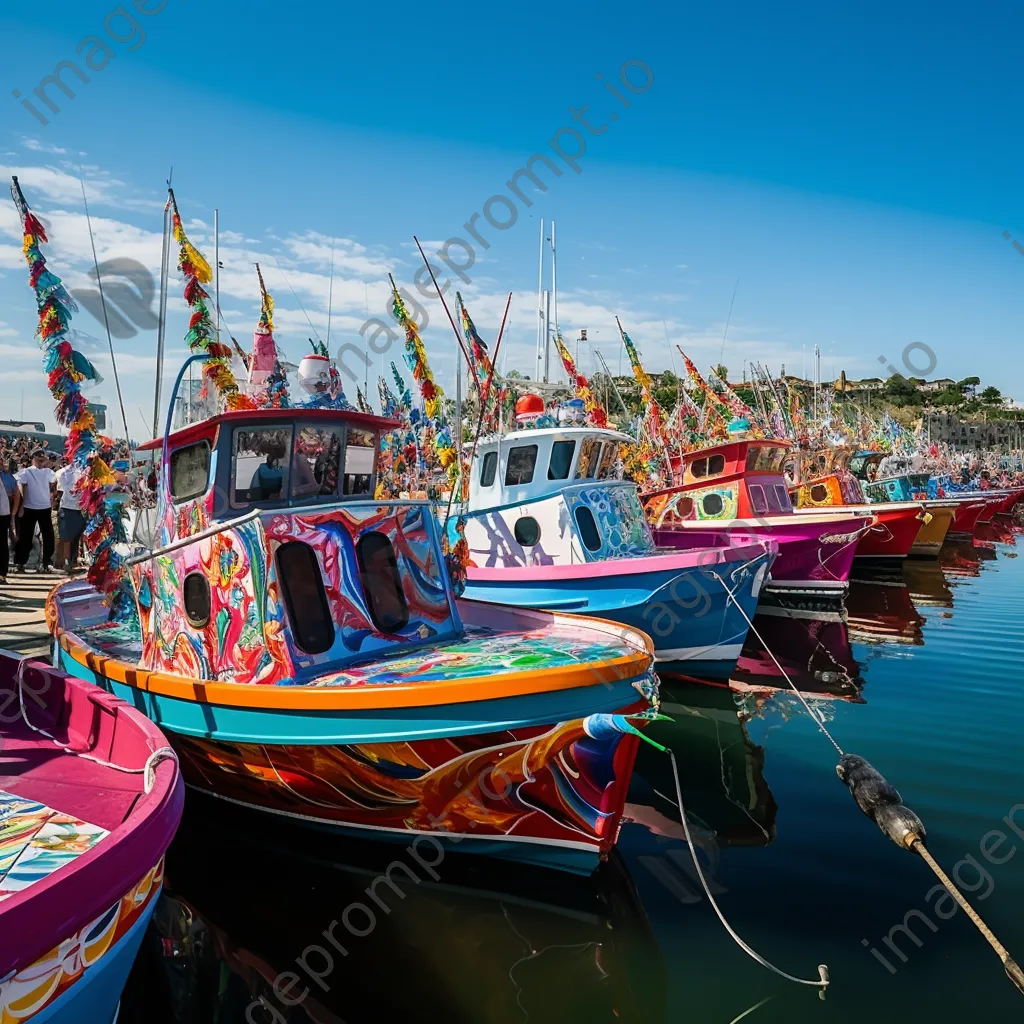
[0,0,1024,433]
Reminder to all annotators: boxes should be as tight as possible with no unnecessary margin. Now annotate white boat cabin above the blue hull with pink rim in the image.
[466,426,654,566]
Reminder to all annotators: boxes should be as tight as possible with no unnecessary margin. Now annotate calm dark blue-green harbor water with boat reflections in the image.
[121,532,1024,1024]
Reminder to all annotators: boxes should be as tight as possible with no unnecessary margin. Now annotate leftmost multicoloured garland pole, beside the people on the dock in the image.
[10,177,128,606]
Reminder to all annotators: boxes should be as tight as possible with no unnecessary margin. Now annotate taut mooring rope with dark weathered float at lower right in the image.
[708,570,1024,992]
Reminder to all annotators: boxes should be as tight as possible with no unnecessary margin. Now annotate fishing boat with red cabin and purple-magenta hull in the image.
[643,438,876,597]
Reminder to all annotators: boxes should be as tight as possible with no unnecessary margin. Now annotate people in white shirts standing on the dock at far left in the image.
[0,433,138,585]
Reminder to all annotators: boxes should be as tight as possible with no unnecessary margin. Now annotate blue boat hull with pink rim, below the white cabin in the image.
[465,543,774,673]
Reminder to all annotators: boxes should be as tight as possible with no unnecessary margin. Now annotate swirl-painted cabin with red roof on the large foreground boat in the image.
[116,409,462,683]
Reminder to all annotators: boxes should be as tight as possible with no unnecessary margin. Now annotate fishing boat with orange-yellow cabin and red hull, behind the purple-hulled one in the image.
[787,445,928,561]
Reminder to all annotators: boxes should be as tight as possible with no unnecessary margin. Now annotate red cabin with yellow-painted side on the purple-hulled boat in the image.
[644,438,793,526]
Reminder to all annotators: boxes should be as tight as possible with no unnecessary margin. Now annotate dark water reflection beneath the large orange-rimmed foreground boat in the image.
[121,795,666,1024]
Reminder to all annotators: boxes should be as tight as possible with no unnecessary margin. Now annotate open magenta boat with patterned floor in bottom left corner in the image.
[0,650,183,1024]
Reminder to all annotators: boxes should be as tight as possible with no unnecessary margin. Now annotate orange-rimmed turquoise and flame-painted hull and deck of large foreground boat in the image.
[51,585,657,873]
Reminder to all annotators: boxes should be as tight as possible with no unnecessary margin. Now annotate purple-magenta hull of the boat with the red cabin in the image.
[654,514,870,597]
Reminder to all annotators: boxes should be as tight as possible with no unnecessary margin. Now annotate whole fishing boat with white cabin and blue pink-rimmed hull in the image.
[449,425,777,672]
